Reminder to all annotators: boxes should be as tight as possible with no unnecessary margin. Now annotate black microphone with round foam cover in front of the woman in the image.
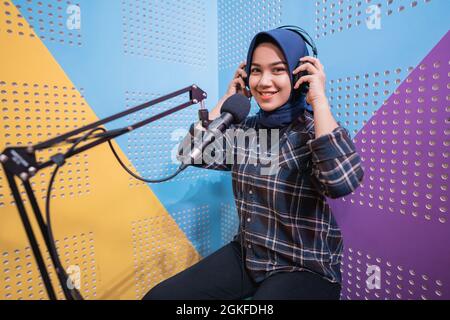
[181,93,250,170]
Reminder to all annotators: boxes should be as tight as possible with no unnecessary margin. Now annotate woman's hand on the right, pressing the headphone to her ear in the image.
[292,56,327,109]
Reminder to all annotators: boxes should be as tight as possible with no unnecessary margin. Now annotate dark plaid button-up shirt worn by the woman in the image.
[178,111,364,283]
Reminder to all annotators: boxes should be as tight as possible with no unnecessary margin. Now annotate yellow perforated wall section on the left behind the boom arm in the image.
[0,1,200,299]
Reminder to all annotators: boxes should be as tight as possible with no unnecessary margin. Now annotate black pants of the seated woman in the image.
[144,241,341,300]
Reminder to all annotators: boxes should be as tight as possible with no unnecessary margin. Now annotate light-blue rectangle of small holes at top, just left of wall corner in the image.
[122,0,207,67]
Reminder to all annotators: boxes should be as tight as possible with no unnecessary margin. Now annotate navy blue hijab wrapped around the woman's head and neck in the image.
[246,29,312,128]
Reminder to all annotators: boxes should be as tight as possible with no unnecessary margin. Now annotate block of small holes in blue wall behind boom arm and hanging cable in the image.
[125,91,211,187]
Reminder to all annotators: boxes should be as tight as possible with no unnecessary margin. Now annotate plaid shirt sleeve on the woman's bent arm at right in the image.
[307,126,364,199]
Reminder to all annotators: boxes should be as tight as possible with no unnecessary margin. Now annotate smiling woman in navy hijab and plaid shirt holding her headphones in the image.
[144,29,364,300]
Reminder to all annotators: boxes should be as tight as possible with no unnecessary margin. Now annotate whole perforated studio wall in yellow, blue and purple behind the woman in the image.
[0,0,450,299]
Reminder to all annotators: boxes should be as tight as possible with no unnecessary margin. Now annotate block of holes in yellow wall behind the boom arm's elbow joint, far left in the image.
[0,79,90,207]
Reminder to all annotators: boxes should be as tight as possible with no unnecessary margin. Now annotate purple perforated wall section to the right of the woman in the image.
[330,32,450,299]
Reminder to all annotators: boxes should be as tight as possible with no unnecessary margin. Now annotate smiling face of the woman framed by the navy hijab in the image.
[249,42,291,111]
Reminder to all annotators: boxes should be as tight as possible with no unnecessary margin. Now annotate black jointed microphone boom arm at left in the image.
[0,85,207,300]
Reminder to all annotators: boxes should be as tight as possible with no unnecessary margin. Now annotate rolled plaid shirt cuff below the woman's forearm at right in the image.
[306,126,356,163]
